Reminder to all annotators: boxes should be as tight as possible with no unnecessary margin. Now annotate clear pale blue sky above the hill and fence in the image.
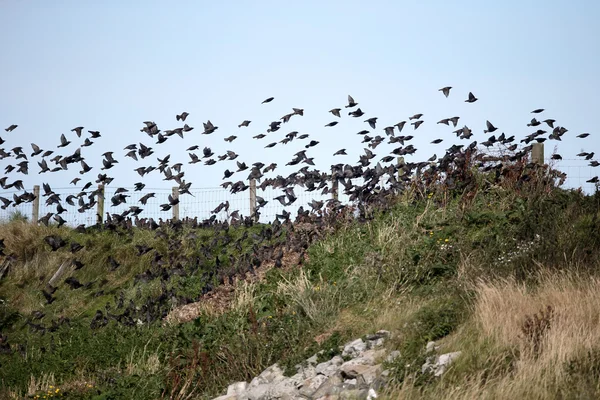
[0,0,600,222]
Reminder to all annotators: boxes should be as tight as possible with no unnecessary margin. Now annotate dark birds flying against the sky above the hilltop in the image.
[0,86,600,230]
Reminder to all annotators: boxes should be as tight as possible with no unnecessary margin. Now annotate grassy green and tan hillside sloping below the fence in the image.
[0,161,600,399]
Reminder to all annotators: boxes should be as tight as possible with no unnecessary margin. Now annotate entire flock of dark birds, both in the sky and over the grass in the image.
[0,86,600,333]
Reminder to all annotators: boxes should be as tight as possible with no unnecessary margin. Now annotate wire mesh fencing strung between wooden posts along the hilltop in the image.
[0,159,600,226]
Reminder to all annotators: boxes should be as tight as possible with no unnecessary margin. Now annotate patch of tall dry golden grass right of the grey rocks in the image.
[385,272,600,399]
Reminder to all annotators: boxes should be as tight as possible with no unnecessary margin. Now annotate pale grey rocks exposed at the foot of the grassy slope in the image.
[213,330,460,400]
